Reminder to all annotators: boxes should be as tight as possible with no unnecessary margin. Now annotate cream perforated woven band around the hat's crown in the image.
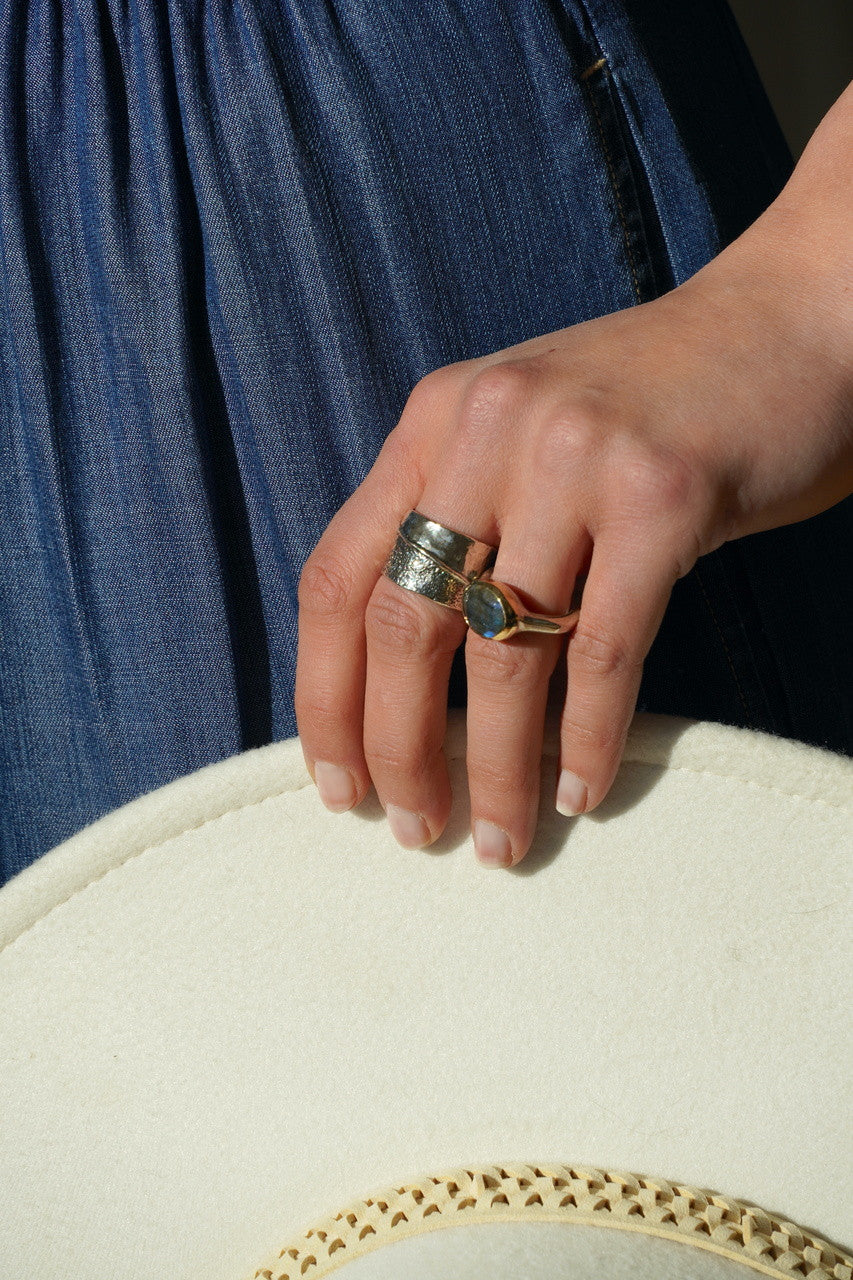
[252,1165,853,1280]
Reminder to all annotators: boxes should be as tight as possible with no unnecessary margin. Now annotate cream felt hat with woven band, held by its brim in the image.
[0,710,853,1280]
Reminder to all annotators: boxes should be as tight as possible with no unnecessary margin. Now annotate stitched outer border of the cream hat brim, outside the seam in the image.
[0,708,853,951]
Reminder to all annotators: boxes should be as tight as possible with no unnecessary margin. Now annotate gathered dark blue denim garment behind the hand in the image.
[0,0,853,881]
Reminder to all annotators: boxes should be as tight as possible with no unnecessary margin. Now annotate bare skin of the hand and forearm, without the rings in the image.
[296,77,853,865]
